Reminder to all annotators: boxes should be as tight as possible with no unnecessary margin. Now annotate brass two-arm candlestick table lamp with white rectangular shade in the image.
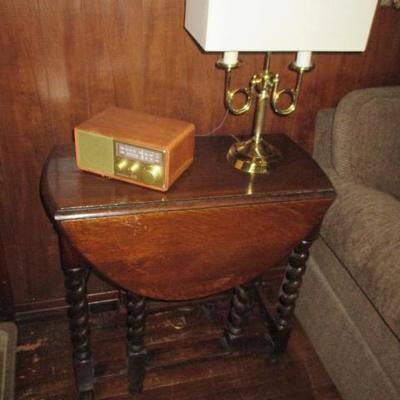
[185,0,377,174]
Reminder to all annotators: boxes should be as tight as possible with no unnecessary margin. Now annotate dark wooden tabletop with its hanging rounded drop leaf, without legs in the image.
[41,135,335,300]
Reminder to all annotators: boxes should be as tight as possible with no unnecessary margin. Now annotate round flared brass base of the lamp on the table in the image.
[227,138,282,174]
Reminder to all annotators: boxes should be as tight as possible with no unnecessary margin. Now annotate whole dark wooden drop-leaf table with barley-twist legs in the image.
[41,135,335,398]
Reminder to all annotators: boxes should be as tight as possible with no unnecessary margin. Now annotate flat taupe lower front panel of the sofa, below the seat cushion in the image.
[296,238,400,400]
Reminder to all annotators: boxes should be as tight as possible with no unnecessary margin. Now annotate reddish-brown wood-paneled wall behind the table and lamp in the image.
[0,0,400,311]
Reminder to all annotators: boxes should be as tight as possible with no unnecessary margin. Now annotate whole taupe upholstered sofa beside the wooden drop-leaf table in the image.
[296,86,400,400]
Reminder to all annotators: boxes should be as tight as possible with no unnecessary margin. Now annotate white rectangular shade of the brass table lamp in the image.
[185,0,377,51]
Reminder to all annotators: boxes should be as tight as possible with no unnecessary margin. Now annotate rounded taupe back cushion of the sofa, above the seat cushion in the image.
[332,86,400,198]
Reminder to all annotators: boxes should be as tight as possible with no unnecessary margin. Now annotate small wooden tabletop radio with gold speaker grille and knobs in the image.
[74,107,194,191]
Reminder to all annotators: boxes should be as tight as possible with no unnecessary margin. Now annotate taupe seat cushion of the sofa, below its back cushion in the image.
[321,172,400,338]
